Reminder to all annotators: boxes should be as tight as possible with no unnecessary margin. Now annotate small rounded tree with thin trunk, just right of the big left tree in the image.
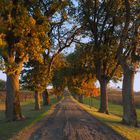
[21,60,50,110]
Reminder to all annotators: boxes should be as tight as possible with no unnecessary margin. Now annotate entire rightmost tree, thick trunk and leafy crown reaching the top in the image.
[116,0,140,126]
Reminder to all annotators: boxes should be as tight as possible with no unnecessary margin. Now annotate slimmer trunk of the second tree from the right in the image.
[99,79,109,114]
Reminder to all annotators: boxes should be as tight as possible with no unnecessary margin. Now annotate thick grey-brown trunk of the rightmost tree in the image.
[122,68,137,126]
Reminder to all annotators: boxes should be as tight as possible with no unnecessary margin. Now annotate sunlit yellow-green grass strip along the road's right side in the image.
[80,97,140,140]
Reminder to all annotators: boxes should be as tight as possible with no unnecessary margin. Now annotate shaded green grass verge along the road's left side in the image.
[0,97,57,140]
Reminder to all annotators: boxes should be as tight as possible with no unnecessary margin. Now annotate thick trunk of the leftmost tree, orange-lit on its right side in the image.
[5,74,23,121]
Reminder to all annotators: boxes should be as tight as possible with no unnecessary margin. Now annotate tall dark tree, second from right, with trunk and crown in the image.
[78,0,123,114]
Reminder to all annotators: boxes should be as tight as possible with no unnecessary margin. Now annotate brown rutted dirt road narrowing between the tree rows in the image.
[14,96,124,140]
